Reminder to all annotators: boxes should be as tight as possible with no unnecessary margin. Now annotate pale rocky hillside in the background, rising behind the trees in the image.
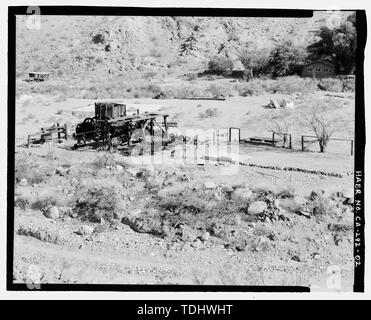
[16,12,352,77]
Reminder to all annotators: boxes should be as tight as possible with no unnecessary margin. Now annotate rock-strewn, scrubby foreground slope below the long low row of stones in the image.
[14,141,353,290]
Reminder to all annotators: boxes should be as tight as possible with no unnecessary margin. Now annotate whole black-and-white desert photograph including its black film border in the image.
[7,4,367,293]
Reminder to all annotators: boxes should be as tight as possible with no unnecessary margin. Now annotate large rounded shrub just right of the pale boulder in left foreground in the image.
[75,179,125,222]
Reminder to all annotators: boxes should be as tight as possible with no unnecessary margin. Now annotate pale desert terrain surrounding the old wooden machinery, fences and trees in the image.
[13,12,355,291]
